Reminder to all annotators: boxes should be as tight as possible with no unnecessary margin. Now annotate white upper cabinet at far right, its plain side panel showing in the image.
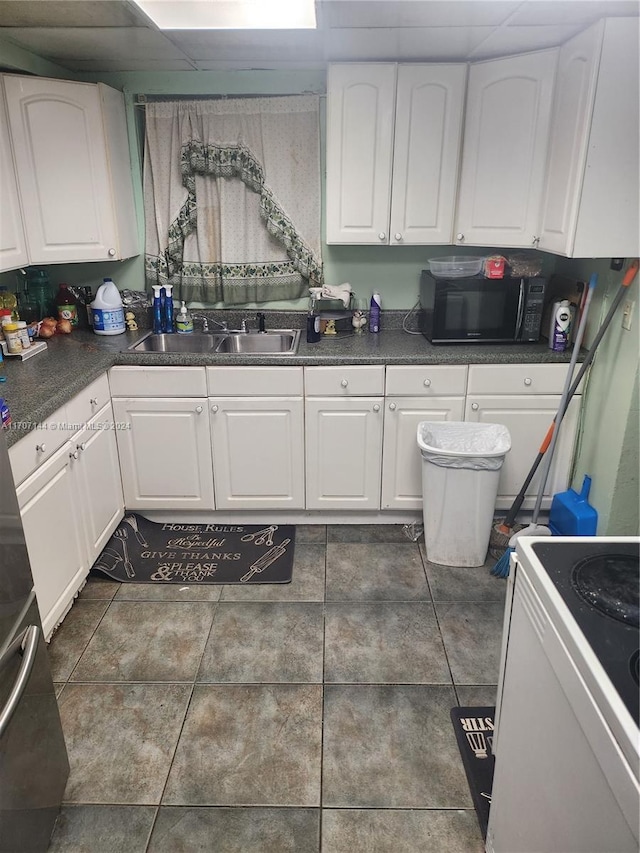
[540,18,640,258]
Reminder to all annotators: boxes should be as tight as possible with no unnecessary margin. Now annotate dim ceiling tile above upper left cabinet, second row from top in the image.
[0,27,190,62]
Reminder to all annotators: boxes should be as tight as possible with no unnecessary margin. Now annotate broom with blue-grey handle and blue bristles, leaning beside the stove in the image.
[491,273,598,578]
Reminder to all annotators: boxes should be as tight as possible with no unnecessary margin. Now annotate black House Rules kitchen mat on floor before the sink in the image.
[92,512,296,584]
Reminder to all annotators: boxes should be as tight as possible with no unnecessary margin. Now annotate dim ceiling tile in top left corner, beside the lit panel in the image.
[0,0,147,27]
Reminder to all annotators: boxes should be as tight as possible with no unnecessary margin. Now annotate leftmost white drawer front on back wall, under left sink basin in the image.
[109,367,207,397]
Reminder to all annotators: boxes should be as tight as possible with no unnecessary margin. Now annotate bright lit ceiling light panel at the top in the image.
[133,0,316,30]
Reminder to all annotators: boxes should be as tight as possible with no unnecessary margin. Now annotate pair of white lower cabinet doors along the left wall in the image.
[12,401,124,638]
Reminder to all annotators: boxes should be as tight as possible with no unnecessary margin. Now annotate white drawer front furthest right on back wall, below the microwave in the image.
[467,363,582,394]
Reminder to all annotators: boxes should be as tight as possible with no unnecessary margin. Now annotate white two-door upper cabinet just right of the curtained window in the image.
[327,63,467,245]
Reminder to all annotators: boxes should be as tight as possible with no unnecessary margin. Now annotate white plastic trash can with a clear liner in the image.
[418,421,511,566]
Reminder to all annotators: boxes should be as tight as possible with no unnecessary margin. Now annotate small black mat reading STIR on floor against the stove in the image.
[451,707,496,839]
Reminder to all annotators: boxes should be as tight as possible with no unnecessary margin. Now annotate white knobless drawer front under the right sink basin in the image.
[206,366,304,397]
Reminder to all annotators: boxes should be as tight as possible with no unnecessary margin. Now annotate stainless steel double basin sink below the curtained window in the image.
[129,329,300,355]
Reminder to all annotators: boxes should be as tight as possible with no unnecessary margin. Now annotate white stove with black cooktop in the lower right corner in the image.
[486,537,640,853]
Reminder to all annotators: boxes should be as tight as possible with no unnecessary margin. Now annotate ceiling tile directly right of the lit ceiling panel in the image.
[318,0,521,28]
